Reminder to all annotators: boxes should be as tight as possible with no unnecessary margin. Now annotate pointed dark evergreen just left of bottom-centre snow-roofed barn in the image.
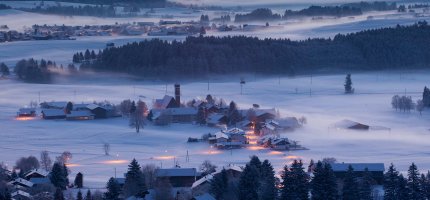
[124,159,146,197]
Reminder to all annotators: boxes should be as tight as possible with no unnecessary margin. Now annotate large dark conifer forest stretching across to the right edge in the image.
[74,21,430,77]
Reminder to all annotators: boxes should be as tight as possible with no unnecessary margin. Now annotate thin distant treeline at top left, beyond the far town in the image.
[21,5,118,17]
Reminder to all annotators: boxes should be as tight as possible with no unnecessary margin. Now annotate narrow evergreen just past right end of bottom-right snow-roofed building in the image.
[384,163,399,199]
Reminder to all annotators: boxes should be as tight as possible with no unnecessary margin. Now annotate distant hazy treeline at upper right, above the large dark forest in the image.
[235,1,397,22]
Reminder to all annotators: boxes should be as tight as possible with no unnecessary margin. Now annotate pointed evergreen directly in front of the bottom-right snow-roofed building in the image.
[342,165,359,200]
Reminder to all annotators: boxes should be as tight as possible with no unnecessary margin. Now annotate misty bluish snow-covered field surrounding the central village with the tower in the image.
[0,71,430,187]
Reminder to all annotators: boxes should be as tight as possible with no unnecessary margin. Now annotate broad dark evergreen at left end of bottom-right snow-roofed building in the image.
[311,161,338,200]
